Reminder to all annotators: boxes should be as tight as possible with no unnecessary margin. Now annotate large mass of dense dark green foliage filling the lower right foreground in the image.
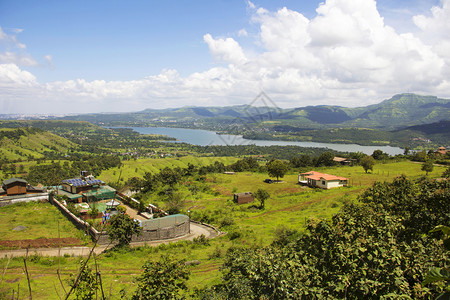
[208,177,450,299]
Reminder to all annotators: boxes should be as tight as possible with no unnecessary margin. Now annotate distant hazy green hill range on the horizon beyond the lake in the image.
[60,94,450,130]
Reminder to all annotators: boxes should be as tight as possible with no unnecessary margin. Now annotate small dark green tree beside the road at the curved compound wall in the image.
[106,214,141,247]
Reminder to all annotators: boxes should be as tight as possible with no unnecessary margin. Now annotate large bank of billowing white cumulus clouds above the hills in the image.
[0,0,450,111]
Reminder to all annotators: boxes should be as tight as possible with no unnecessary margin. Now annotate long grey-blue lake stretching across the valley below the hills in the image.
[118,127,403,155]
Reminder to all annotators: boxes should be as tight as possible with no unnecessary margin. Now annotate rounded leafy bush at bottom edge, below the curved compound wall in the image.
[132,256,190,300]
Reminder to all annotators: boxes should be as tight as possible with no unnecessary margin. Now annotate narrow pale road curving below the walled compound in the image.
[0,223,217,258]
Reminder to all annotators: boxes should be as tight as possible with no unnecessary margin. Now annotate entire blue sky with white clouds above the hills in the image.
[0,0,450,113]
